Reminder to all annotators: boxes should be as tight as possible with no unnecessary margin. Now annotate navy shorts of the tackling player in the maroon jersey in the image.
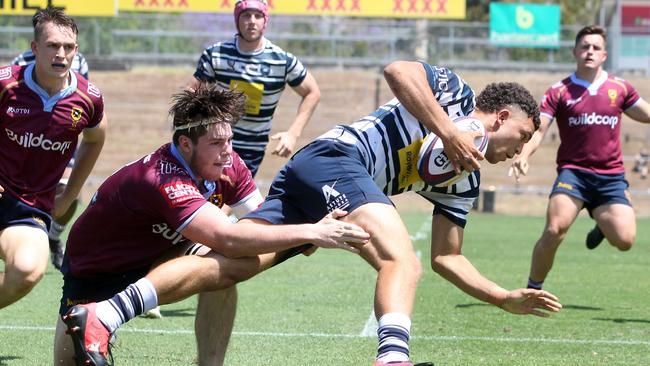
[59,264,149,315]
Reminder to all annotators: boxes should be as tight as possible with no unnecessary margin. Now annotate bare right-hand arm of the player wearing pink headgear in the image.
[271,71,320,157]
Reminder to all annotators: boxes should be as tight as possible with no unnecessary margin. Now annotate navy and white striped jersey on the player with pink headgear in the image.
[194,36,307,151]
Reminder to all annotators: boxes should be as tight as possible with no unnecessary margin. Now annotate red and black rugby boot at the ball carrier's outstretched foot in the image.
[63,302,112,366]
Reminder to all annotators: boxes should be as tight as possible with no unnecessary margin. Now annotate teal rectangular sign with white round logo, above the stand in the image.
[490,3,560,48]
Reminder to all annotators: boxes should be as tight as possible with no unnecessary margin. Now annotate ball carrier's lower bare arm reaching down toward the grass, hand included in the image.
[431,214,562,317]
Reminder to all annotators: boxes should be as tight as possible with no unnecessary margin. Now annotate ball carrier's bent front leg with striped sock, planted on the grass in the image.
[344,203,422,364]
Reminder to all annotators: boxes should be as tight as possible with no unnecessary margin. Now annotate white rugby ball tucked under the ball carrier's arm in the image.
[418,117,489,187]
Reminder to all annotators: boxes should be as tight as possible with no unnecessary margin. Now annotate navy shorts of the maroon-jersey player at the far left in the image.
[0,191,52,233]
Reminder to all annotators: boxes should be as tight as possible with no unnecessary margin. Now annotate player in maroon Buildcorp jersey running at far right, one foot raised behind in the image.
[511,26,650,288]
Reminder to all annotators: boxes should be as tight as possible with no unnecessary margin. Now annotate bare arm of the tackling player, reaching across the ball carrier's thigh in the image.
[181,204,370,258]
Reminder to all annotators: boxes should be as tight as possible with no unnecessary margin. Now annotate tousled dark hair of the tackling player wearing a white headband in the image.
[169,83,245,145]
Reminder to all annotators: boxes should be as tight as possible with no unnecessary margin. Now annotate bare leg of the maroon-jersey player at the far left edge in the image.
[0,225,48,309]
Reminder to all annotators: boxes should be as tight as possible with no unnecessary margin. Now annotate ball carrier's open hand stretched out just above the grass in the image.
[501,288,562,318]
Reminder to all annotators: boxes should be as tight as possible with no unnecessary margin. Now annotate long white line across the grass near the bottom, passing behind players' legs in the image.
[0,325,650,347]
